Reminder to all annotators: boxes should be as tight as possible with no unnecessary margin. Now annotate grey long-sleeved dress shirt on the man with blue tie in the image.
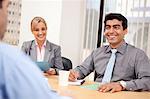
[75,42,150,91]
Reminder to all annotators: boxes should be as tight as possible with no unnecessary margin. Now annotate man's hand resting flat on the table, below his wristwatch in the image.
[98,82,124,93]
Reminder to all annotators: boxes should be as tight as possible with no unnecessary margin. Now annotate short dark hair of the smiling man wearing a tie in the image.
[104,13,128,30]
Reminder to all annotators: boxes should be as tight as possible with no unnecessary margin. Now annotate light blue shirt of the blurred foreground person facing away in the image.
[0,43,69,99]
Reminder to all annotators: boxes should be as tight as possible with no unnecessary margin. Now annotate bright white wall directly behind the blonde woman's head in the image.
[19,0,61,47]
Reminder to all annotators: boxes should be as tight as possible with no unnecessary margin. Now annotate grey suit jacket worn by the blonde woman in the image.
[22,40,63,73]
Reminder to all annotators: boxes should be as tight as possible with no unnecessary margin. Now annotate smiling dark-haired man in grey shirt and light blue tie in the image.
[69,13,150,92]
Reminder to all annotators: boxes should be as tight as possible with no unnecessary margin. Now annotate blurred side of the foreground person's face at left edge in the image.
[0,0,9,39]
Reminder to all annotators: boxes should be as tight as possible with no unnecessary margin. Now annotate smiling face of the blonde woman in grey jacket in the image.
[32,22,47,42]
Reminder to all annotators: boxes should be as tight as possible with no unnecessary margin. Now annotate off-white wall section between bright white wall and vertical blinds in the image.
[60,0,84,67]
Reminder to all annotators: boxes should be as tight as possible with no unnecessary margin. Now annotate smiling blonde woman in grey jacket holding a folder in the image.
[22,17,63,75]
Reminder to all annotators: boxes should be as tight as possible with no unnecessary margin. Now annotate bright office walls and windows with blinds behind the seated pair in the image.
[4,0,150,72]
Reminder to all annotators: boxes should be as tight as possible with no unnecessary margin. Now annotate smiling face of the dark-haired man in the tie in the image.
[104,19,127,48]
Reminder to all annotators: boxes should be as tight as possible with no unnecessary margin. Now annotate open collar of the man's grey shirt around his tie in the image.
[105,41,127,54]
